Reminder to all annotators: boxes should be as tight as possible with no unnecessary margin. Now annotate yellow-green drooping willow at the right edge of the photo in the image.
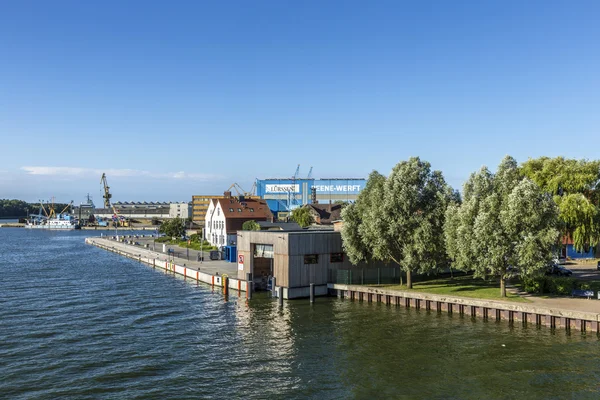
[522,157,600,251]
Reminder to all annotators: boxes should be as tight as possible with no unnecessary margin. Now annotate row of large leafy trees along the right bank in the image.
[342,156,600,296]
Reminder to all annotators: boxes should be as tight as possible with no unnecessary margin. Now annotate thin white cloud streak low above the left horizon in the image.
[21,166,222,181]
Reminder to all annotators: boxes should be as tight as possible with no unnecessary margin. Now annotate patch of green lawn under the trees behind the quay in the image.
[385,276,530,303]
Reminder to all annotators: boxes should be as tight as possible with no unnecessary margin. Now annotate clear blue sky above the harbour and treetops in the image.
[0,0,600,203]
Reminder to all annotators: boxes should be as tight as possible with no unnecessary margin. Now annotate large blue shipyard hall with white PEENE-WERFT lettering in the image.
[256,178,367,219]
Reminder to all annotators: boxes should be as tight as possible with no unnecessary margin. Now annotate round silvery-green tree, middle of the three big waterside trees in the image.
[444,156,558,297]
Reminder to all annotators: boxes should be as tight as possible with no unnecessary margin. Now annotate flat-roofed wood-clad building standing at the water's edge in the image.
[237,230,366,299]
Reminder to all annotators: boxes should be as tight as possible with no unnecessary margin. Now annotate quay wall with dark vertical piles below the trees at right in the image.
[328,284,600,335]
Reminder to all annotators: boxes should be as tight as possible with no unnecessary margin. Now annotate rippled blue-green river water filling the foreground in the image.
[0,229,600,399]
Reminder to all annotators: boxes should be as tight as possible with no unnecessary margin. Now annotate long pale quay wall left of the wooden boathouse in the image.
[85,238,248,293]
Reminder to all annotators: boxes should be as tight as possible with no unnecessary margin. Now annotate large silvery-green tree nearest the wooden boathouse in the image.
[342,157,453,288]
